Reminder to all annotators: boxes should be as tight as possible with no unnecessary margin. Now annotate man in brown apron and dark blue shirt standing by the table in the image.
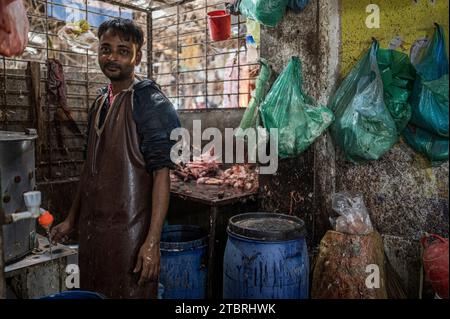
[52,18,180,298]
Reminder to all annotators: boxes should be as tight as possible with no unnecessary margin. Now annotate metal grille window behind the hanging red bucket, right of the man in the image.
[149,0,258,109]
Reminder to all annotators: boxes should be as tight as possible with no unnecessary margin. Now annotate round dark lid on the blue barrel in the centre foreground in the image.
[227,213,306,241]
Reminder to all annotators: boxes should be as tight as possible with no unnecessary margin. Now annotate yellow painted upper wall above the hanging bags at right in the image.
[340,0,449,75]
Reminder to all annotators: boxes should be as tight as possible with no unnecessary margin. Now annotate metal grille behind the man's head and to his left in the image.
[0,0,148,182]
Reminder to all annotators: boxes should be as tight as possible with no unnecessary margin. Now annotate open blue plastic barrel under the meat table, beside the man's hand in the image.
[159,225,208,299]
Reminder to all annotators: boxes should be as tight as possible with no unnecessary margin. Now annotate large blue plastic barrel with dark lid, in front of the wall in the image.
[223,213,309,299]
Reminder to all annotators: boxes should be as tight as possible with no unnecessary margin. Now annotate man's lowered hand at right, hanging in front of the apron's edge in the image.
[134,242,161,285]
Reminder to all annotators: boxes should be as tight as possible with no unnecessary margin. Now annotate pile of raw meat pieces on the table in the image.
[171,149,258,190]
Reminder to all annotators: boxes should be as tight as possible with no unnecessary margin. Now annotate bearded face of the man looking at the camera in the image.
[98,30,142,81]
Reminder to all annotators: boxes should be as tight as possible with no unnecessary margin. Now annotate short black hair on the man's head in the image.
[98,18,144,50]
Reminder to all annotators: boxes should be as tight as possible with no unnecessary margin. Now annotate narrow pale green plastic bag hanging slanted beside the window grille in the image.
[235,58,272,137]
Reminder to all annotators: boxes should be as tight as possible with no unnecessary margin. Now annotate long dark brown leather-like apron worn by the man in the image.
[79,89,157,299]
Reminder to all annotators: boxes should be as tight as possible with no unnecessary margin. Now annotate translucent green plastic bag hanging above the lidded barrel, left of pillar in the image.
[261,57,334,158]
